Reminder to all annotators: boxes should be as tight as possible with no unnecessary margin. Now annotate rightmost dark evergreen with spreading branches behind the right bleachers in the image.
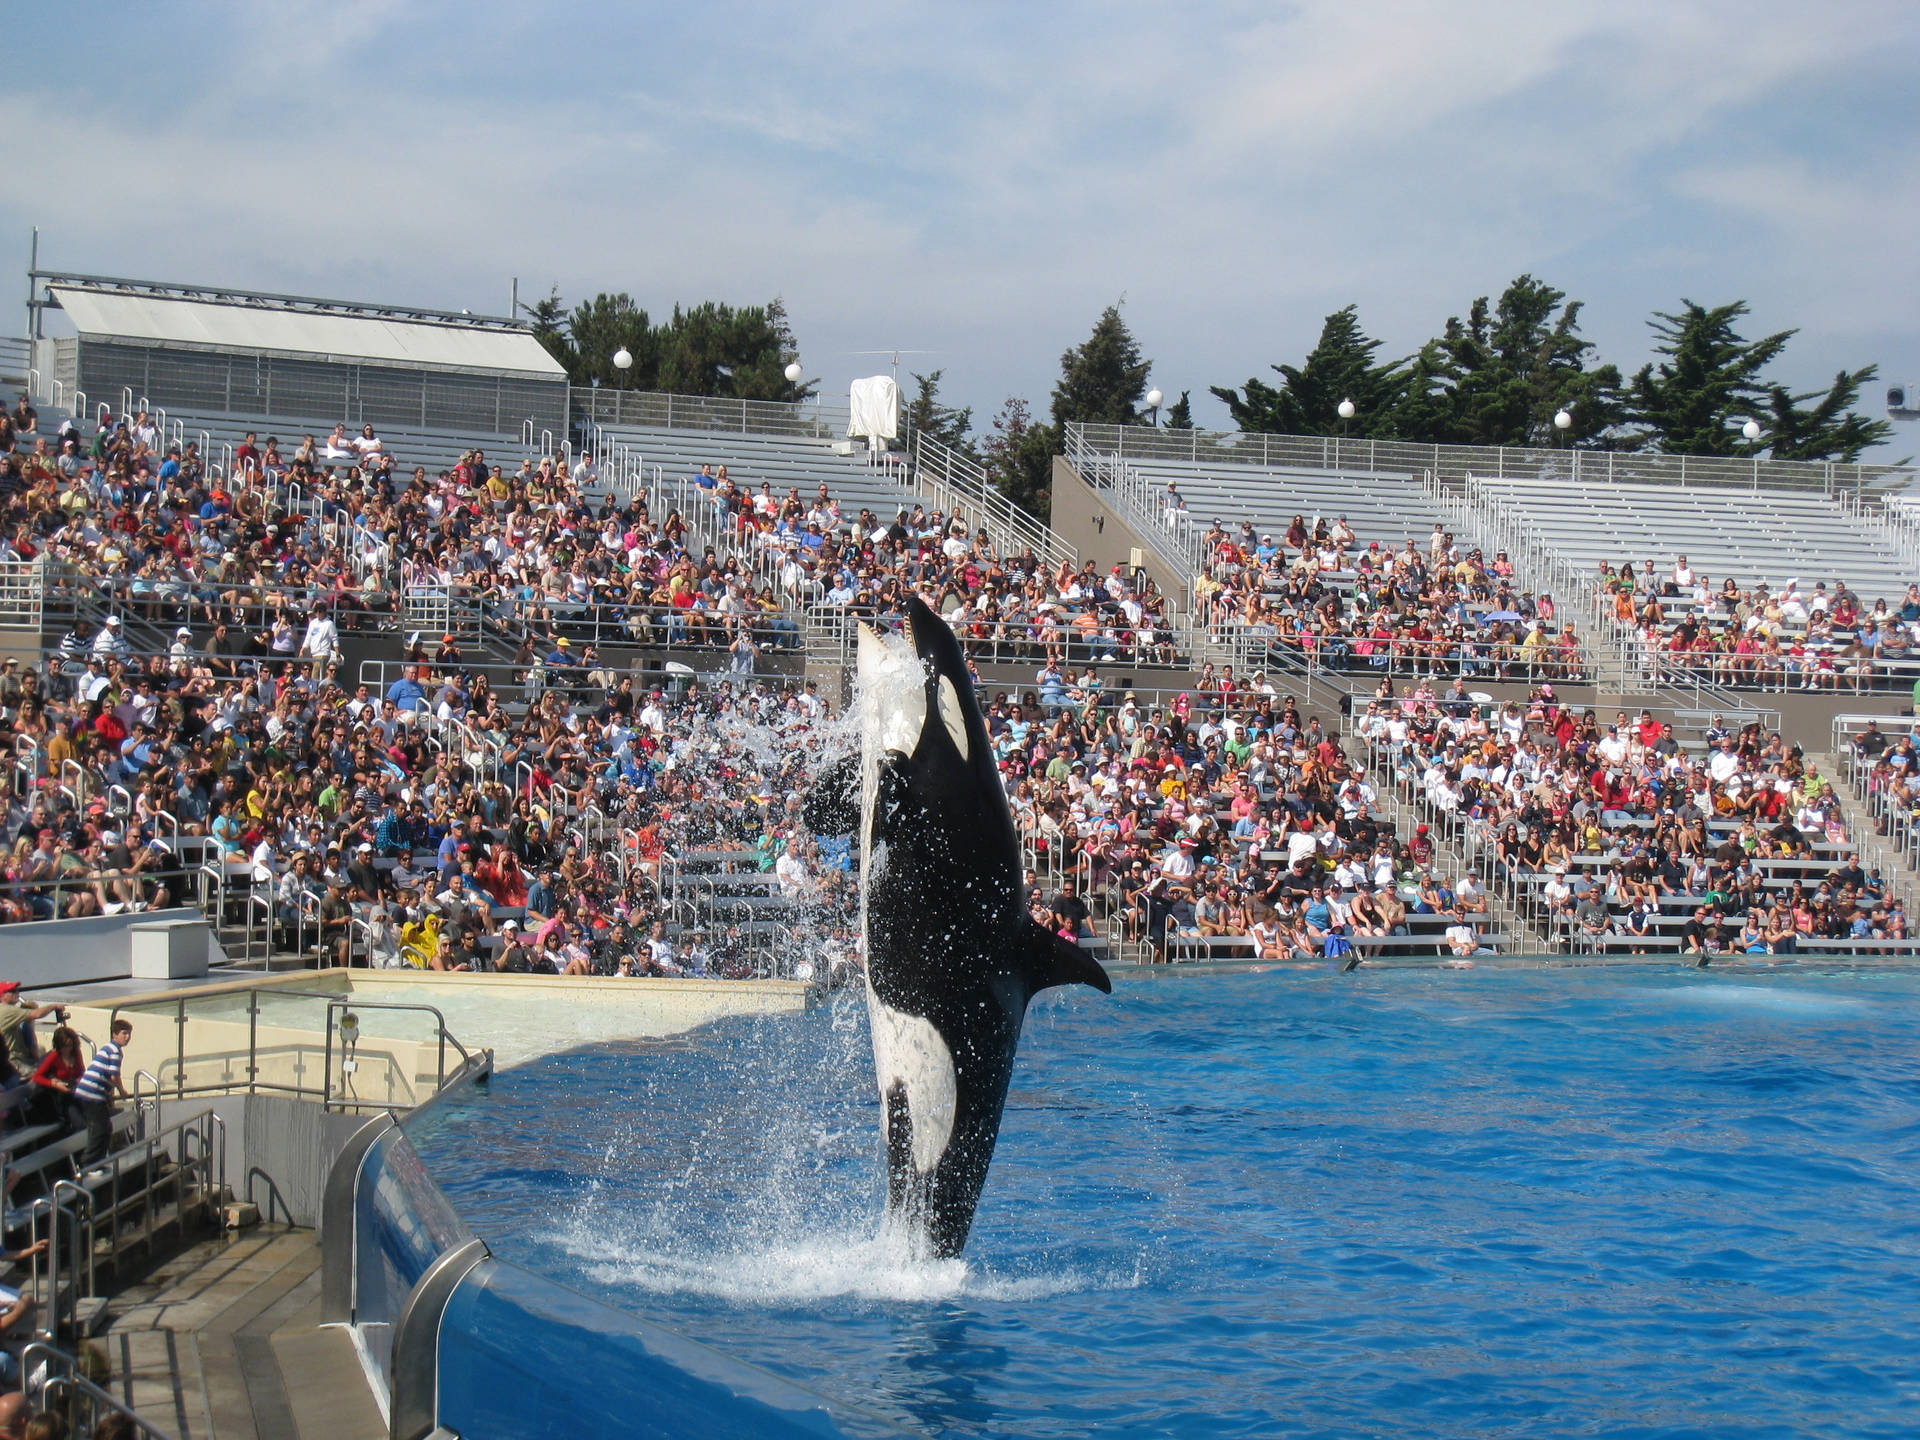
[1632,300,1891,461]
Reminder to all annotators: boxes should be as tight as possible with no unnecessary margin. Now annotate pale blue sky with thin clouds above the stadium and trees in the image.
[0,0,1920,455]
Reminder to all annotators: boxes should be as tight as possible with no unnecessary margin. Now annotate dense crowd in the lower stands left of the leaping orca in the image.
[0,599,864,973]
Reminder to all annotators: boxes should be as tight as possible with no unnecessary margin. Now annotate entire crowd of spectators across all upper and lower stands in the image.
[15,395,1920,973]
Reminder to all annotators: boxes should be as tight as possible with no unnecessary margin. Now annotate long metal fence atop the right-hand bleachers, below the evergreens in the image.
[1068,420,1914,495]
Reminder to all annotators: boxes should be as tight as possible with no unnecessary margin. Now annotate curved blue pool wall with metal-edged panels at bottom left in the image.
[321,1044,904,1440]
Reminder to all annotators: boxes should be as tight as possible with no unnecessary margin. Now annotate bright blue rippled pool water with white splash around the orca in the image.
[417,970,1920,1436]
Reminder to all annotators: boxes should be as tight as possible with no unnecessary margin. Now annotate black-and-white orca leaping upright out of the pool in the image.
[803,599,1114,1260]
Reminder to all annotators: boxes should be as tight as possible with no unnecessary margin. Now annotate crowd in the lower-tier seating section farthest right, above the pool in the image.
[1359,685,1908,954]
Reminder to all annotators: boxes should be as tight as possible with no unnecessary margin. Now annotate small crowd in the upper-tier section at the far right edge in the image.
[1597,555,1920,693]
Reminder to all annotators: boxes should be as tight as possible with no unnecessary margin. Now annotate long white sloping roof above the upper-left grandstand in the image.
[48,284,566,378]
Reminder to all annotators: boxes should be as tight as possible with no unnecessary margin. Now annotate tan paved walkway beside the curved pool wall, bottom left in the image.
[96,1225,388,1440]
